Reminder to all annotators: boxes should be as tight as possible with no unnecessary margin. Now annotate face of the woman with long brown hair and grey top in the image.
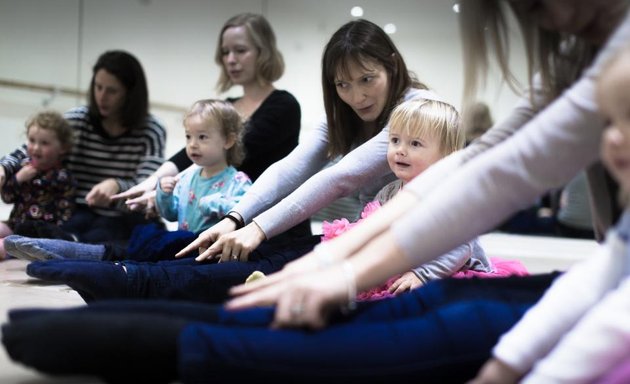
[335,61,389,122]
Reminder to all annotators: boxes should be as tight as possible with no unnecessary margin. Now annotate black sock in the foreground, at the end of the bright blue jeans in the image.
[2,310,186,383]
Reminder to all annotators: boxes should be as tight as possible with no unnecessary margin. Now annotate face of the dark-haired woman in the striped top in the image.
[94,69,127,119]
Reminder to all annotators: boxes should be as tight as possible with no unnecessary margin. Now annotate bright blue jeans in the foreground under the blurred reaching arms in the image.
[179,274,556,383]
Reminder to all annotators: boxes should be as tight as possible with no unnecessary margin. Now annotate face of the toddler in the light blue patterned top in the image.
[185,116,231,170]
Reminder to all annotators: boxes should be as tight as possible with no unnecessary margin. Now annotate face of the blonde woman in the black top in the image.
[221,26,258,85]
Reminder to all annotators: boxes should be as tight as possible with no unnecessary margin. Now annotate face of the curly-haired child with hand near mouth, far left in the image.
[26,124,65,171]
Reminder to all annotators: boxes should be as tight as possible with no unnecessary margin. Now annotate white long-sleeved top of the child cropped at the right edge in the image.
[494,211,630,384]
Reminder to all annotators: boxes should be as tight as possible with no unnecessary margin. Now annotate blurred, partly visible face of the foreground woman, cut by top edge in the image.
[509,0,625,44]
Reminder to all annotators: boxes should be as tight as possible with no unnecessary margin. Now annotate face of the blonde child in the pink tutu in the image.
[387,132,443,183]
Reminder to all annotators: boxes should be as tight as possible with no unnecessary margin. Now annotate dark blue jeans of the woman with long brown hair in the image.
[122,236,320,303]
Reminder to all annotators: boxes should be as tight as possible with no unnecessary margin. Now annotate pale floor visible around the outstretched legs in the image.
[0,230,596,384]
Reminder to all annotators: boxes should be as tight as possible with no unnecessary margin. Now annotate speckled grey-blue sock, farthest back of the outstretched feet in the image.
[4,235,105,260]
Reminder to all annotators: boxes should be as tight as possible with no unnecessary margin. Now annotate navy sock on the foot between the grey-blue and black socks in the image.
[26,260,128,303]
